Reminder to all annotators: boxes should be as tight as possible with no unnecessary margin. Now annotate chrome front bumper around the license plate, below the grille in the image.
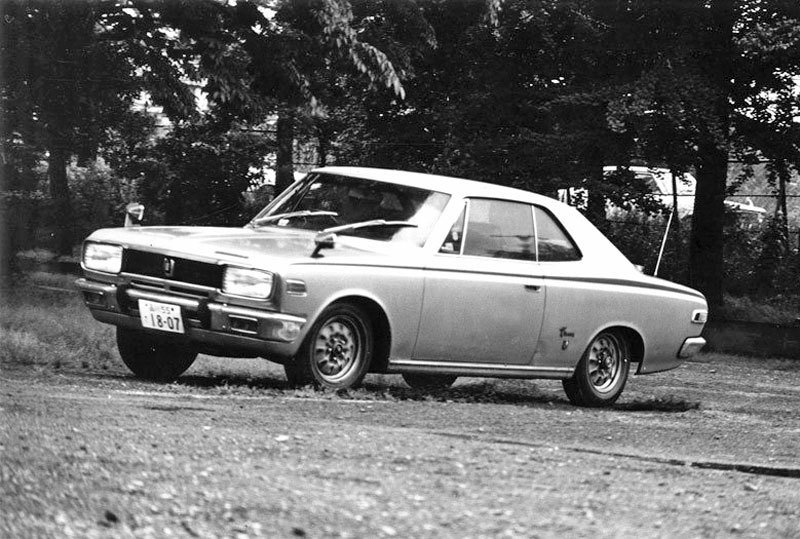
[75,278,306,357]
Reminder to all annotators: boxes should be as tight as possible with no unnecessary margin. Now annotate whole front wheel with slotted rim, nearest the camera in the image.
[294,303,373,389]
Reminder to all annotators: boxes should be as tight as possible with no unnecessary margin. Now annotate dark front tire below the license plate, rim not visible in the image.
[117,327,197,382]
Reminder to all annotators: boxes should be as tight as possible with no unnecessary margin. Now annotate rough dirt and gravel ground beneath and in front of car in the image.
[0,356,800,537]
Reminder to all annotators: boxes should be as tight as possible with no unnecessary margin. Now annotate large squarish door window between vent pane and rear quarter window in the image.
[463,199,536,260]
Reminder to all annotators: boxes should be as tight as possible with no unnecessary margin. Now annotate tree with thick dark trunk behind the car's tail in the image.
[600,0,800,310]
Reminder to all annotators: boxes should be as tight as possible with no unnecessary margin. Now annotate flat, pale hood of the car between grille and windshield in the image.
[87,226,386,265]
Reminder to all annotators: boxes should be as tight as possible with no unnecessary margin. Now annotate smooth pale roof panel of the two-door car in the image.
[311,167,557,205]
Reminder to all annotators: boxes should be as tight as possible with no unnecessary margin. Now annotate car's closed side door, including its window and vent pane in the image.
[413,198,545,365]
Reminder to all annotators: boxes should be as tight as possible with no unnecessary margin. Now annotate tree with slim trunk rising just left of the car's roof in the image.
[247,0,426,192]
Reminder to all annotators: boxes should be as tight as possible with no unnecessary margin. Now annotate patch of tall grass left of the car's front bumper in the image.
[0,273,117,368]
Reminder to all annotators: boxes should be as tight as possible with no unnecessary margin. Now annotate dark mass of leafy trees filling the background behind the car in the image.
[0,0,800,312]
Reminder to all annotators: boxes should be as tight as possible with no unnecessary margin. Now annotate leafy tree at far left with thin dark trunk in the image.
[2,0,263,253]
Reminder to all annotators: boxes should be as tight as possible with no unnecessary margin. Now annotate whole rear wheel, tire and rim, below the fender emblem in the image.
[562,331,630,408]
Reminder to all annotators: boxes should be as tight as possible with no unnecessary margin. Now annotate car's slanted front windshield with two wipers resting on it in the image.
[251,174,450,247]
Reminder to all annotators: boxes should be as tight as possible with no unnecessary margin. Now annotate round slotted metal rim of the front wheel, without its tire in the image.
[313,315,362,382]
